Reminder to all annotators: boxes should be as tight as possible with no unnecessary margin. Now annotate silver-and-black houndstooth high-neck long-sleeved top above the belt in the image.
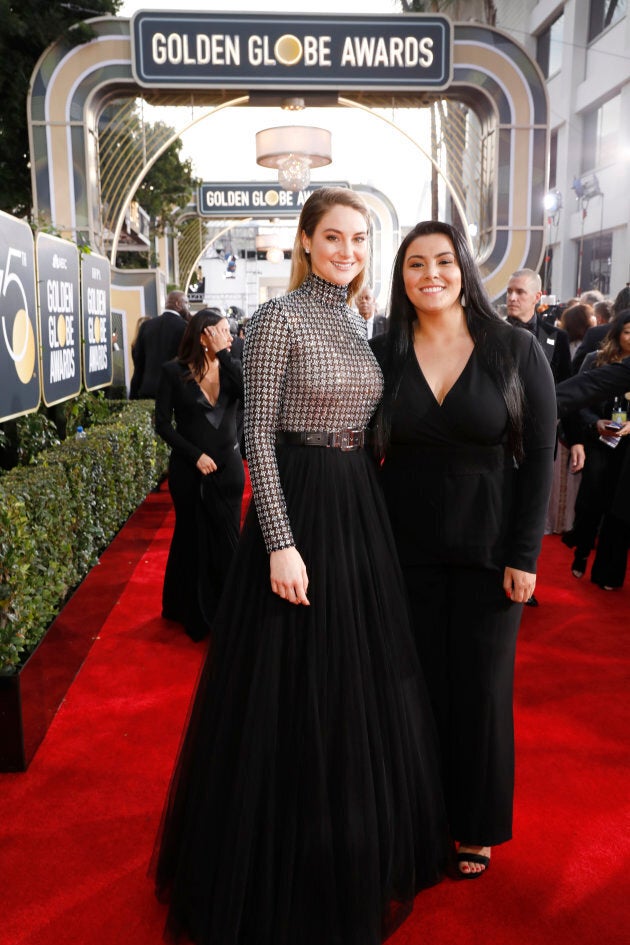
[243,275,383,552]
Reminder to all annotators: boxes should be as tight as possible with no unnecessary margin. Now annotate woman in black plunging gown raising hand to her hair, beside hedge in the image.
[155,309,245,640]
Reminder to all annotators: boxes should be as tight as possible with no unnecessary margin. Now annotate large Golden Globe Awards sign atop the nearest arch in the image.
[131,11,453,92]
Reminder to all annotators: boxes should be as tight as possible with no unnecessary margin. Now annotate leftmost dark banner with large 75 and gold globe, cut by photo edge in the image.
[0,211,40,422]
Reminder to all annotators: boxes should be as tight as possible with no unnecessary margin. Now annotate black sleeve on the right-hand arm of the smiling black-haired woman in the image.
[506,328,557,573]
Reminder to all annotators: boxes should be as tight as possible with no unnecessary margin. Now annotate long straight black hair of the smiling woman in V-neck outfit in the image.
[376,220,525,462]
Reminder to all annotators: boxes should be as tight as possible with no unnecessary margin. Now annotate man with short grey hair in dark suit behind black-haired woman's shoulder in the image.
[506,269,571,384]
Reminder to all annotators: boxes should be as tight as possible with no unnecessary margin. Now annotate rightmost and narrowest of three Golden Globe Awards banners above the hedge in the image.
[81,253,113,390]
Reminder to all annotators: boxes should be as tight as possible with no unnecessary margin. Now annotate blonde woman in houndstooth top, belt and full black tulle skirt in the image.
[155,188,446,945]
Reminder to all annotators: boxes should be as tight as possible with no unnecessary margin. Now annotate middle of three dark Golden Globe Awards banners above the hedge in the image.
[35,233,81,407]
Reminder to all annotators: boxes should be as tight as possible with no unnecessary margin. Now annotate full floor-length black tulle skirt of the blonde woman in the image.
[153,447,447,945]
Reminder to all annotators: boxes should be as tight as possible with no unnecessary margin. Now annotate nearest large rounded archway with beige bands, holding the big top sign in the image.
[29,13,548,298]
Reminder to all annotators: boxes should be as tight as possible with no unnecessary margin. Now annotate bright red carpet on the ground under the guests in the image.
[0,491,630,945]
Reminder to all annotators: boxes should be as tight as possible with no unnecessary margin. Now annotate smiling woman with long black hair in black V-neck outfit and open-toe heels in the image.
[372,221,556,878]
